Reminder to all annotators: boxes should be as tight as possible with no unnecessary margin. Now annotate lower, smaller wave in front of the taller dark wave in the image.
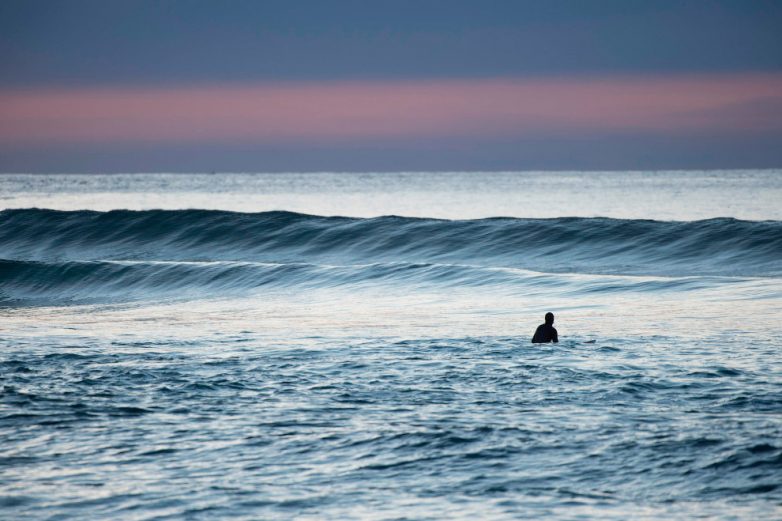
[0,259,782,307]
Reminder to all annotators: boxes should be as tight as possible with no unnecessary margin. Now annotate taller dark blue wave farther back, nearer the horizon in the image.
[0,209,782,276]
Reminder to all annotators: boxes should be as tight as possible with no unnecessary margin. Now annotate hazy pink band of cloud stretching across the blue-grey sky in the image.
[0,74,782,145]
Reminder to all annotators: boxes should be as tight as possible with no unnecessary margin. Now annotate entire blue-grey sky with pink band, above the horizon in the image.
[0,0,782,172]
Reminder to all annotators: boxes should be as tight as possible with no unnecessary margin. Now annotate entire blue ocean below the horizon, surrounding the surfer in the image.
[0,170,782,520]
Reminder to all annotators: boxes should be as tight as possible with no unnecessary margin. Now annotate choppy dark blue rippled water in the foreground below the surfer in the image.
[0,337,782,519]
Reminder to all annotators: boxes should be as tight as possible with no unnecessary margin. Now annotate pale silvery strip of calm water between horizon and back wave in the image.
[0,170,782,220]
